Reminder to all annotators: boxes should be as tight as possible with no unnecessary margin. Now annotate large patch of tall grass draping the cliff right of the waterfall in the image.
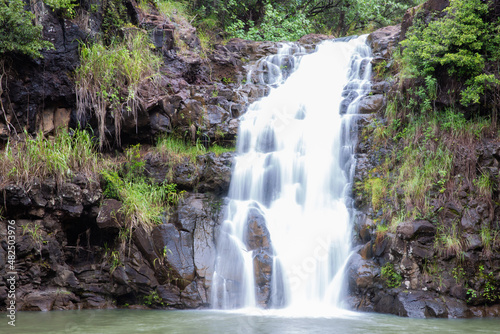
[373,104,492,218]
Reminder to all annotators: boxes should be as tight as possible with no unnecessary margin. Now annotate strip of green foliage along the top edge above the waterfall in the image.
[190,0,421,40]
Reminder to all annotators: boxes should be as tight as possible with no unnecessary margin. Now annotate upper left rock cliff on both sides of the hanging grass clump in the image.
[0,1,278,145]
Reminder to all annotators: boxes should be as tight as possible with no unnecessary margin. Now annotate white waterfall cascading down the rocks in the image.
[212,36,371,309]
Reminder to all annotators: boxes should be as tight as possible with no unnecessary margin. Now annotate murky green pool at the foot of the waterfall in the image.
[0,310,500,334]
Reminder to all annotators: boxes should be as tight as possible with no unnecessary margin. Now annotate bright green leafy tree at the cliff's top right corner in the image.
[401,0,500,109]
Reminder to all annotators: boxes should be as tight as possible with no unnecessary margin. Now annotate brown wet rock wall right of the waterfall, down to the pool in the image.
[347,6,500,318]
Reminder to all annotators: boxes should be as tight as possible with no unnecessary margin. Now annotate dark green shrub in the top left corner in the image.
[0,0,54,58]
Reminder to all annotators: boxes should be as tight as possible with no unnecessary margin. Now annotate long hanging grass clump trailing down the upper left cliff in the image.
[75,29,161,148]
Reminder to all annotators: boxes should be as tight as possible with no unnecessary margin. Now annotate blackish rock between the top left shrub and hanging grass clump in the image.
[2,8,86,139]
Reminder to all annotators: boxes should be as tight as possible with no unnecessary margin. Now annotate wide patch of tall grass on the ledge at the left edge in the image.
[0,130,100,184]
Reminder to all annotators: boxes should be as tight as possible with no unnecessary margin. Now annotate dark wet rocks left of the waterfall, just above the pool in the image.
[0,178,227,311]
